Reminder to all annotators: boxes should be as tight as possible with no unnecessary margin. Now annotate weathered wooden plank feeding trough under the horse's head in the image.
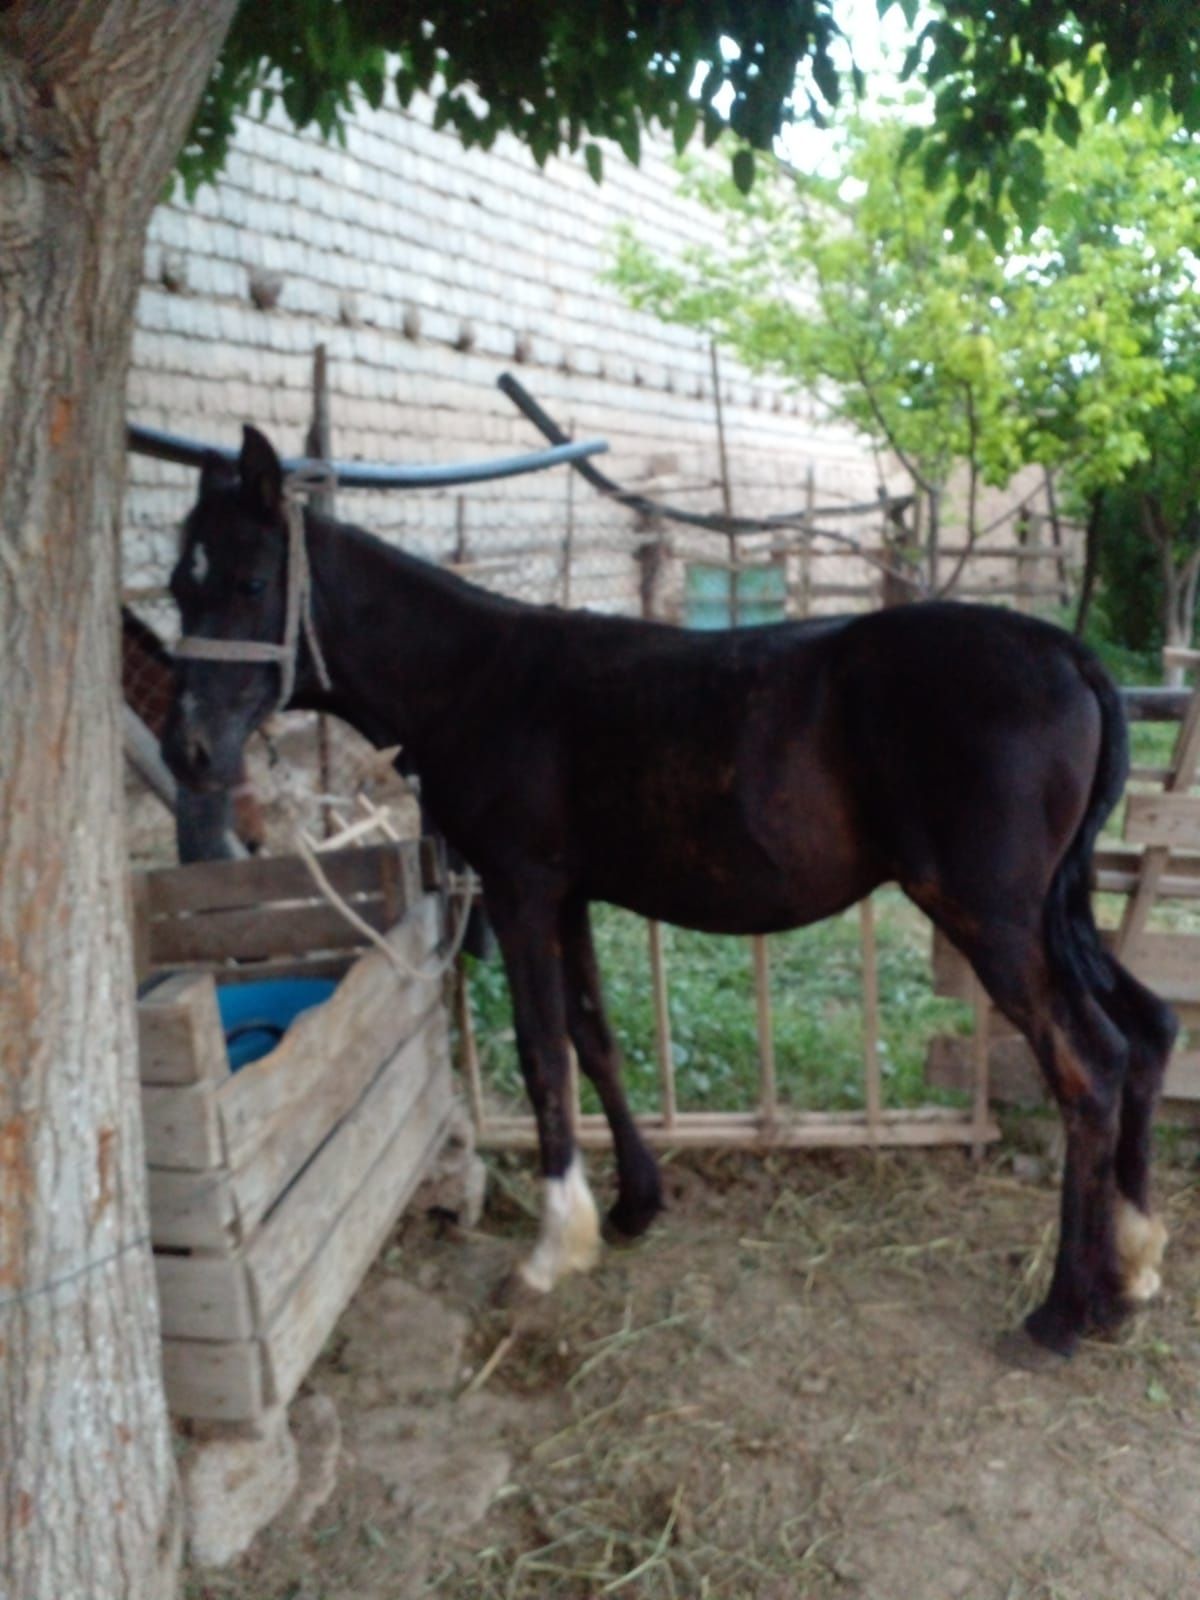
[134,842,451,1422]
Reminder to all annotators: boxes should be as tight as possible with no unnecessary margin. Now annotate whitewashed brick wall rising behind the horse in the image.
[125,84,883,630]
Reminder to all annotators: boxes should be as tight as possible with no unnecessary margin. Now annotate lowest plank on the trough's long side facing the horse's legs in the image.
[262,1072,453,1405]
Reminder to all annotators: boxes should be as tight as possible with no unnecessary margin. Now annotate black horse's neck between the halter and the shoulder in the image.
[304,515,514,760]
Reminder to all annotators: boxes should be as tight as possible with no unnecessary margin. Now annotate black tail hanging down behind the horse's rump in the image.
[1045,646,1130,994]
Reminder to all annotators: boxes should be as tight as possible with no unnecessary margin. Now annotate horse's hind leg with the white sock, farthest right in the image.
[1101,958,1179,1304]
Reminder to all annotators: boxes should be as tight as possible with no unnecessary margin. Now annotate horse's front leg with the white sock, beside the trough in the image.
[486,886,600,1294]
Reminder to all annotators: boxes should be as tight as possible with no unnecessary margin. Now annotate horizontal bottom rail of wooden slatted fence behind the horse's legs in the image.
[478,1106,1000,1150]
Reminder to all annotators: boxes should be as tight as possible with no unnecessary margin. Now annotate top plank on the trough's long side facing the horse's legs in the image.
[218,896,442,1232]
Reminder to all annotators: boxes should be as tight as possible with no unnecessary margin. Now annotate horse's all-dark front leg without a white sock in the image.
[562,901,662,1238]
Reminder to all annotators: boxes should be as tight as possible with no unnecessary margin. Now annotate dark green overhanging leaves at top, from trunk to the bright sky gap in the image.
[181,0,842,186]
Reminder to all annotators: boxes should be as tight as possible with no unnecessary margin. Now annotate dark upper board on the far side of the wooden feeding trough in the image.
[146,838,421,918]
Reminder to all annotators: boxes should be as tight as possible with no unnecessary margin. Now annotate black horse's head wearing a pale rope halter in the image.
[163,427,294,789]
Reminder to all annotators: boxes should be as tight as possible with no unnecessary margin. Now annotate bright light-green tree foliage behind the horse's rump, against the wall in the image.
[614,112,1200,624]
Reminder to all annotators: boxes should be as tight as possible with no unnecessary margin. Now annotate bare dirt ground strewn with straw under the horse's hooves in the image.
[187,1154,1200,1600]
